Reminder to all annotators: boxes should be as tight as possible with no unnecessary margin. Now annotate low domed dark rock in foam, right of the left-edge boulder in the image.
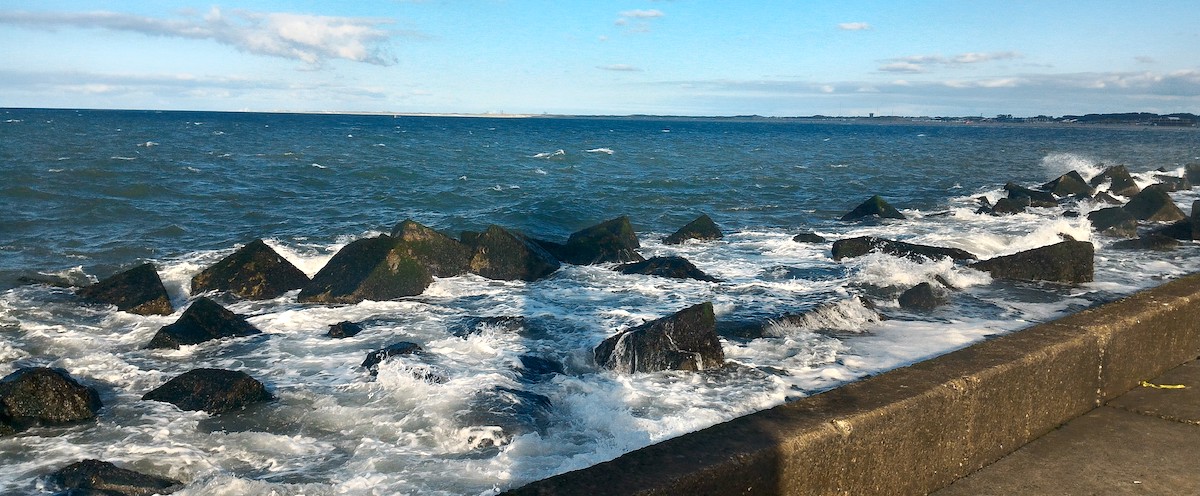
[142,369,274,416]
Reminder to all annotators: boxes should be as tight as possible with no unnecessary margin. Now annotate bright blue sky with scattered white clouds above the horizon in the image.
[0,0,1200,116]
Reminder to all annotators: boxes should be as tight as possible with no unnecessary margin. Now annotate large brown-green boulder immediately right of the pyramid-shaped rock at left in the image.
[299,234,433,303]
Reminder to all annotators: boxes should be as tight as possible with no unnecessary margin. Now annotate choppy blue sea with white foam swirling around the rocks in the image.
[0,108,1200,495]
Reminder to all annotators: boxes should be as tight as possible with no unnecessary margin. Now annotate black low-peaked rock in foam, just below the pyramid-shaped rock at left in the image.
[146,297,262,349]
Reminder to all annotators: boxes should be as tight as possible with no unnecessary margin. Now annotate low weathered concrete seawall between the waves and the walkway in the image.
[510,275,1200,495]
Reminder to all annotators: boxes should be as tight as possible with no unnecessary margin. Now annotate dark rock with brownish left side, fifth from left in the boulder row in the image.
[470,226,562,281]
